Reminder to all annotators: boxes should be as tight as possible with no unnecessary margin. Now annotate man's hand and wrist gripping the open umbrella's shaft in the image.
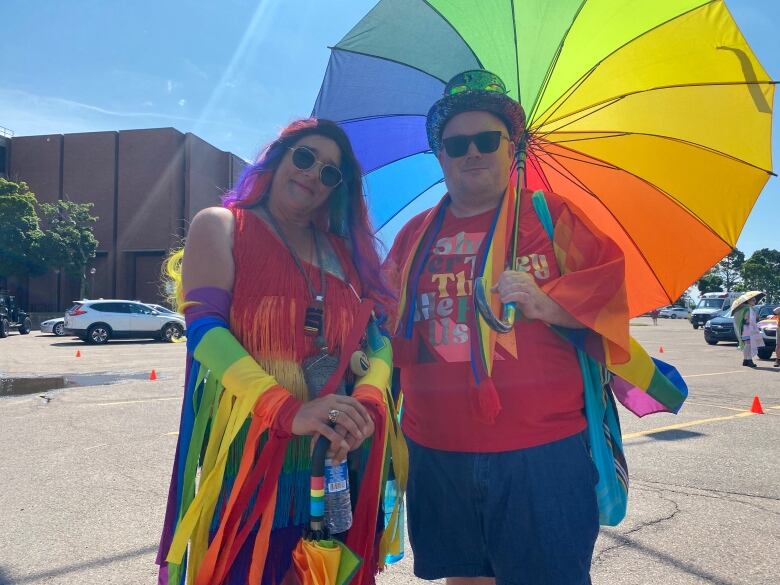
[490,270,583,329]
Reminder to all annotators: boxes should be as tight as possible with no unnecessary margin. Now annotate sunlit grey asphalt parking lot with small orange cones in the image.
[0,319,780,585]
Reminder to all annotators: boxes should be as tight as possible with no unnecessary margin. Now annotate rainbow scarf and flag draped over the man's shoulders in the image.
[396,185,688,422]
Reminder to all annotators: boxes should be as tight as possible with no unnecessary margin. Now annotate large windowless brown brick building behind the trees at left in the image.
[0,128,245,312]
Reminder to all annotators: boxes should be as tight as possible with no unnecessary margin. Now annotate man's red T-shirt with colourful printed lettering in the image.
[390,192,585,452]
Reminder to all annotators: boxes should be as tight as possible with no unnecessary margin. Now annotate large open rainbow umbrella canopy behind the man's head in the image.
[313,0,775,315]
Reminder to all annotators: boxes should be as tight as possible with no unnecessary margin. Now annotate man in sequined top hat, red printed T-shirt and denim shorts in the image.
[384,70,628,585]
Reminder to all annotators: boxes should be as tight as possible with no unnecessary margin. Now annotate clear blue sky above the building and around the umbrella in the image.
[0,0,780,255]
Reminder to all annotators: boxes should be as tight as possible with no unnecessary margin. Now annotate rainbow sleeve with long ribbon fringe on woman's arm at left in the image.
[158,288,300,584]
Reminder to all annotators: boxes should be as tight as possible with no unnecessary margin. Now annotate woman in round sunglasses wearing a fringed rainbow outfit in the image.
[157,119,406,585]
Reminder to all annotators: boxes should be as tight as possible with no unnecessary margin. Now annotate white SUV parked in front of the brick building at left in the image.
[65,299,185,344]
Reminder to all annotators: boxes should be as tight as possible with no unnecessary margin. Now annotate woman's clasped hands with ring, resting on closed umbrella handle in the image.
[292,394,374,462]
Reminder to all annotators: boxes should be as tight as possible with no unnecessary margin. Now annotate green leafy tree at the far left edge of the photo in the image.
[0,177,46,277]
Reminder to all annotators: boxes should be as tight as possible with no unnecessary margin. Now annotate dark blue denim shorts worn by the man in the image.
[407,432,599,585]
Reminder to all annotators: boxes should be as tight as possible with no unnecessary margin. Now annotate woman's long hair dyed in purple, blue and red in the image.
[222,118,392,313]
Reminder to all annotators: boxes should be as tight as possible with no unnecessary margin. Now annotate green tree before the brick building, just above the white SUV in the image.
[40,200,98,298]
